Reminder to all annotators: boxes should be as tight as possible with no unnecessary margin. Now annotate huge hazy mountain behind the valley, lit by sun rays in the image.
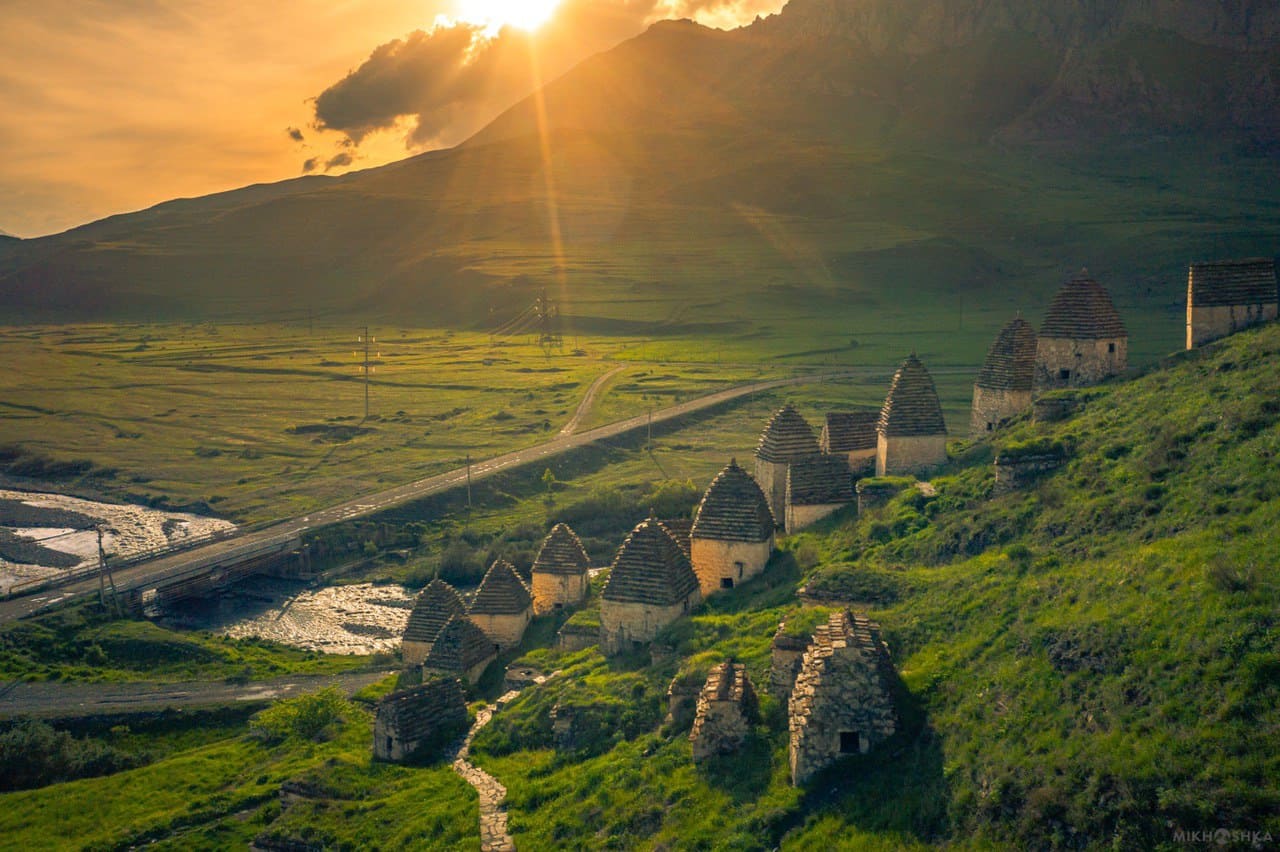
[0,0,1280,332]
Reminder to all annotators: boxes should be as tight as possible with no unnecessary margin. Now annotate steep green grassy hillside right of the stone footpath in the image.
[477,326,1280,848]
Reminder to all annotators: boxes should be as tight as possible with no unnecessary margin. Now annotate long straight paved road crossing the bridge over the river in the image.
[0,370,869,624]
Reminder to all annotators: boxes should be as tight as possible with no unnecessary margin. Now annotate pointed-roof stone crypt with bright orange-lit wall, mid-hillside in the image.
[690,459,774,597]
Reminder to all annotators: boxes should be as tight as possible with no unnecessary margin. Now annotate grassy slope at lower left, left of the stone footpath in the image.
[0,706,479,849]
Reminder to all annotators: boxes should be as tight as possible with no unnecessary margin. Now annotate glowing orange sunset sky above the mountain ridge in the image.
[0,0,782,237]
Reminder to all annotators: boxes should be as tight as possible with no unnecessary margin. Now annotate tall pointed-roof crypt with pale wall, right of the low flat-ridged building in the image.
[876,352,947,476]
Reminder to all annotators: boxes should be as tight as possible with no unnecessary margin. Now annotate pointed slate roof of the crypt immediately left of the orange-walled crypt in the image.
[600,516,698,606]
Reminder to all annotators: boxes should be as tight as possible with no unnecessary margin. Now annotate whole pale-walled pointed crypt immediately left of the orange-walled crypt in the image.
[600,516,701,654]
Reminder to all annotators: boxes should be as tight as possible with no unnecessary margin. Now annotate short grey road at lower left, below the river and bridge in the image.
[0,672,394,719]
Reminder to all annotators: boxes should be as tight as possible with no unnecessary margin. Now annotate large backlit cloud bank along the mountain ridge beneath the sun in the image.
[315,0,780,147]
